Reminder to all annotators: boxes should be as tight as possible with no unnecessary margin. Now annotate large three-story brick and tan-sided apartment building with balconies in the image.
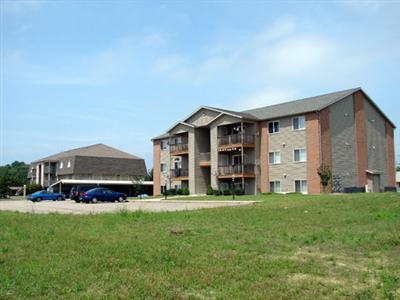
[152,88,396,194]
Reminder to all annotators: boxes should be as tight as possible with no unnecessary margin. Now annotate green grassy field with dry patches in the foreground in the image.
[0,193,400,299]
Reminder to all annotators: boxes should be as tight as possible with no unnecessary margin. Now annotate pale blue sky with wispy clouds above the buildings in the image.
[0,0,400,168]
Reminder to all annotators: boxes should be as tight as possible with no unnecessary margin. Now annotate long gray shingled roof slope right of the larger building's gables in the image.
[244,88,360,120]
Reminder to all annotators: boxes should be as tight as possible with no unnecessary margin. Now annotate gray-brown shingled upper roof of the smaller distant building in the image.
[34,144,141,162]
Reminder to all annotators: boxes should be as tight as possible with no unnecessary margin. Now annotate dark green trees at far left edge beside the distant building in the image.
[0,161,29,193]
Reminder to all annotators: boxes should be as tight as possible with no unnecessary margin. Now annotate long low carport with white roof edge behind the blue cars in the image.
[48,179,153,196]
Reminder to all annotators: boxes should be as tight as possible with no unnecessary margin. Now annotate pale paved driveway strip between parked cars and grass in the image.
[0,200,254,214]
